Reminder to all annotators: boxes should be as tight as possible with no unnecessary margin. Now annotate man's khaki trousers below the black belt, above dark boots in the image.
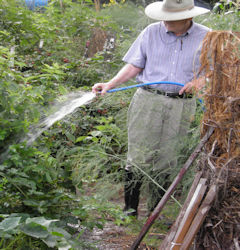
[126,88,196,209]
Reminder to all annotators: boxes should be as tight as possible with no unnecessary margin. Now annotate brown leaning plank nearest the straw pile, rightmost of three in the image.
[180,185,217,250]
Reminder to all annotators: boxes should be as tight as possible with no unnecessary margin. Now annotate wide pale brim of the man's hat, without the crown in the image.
[145,2,210,21]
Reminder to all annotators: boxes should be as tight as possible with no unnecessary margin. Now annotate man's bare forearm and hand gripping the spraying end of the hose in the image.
[92,64,143,95]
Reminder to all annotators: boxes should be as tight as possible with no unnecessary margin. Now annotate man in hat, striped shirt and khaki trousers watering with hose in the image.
[92,0,209,215]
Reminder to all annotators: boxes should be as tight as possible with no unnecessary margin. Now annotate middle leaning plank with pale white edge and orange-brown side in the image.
[171,178,207,250]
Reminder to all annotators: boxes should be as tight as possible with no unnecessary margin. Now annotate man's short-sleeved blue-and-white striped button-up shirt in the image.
[123,22,210,92]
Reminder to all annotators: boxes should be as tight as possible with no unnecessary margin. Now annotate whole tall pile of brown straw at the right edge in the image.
[196,31,240,249]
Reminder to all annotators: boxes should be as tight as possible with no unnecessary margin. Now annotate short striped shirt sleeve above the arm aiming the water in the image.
[122,29,147,68]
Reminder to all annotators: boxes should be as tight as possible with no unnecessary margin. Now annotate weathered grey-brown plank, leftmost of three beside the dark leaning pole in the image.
[159,172,202,250]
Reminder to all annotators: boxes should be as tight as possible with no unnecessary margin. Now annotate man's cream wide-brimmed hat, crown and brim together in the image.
[145,0,210,21]
